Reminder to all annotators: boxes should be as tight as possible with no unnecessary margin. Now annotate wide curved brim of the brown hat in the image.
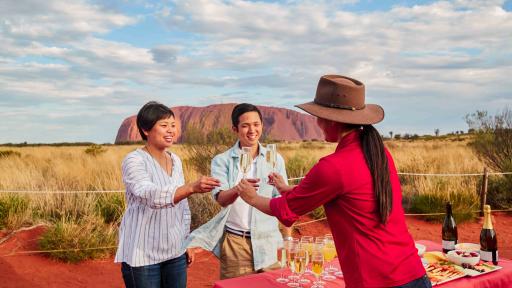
[295,102,384,125]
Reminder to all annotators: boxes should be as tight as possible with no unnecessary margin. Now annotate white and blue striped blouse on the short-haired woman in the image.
[115,149,191,267]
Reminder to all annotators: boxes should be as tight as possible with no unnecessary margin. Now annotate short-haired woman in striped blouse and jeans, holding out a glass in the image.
[115,101,220,288]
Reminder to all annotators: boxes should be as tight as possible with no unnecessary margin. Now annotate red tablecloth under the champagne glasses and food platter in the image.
[213,240,512,288]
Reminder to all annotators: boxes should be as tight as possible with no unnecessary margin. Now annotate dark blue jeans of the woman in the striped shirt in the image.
[121,254,187,288]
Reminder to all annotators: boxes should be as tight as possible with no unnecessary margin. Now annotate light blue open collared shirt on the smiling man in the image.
[185,142,288,270]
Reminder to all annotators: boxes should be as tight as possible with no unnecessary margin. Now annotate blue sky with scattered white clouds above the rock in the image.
[0,0,512,143]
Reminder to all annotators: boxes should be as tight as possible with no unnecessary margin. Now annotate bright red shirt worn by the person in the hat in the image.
[270,131,425,288]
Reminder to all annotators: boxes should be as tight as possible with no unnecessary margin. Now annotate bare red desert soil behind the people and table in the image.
[0,213,512,288]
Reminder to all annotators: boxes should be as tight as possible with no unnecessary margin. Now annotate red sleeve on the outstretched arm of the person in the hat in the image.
[270,158,342,226]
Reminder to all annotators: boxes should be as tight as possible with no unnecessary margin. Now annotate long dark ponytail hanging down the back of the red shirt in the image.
[361,125,393,224]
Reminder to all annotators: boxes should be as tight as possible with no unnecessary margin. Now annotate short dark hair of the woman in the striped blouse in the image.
[137,101,174,141]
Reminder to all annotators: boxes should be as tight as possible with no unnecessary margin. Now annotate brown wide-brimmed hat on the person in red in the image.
[295,75,384,125]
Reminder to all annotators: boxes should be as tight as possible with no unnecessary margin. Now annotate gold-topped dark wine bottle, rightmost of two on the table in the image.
[480,205,498,265]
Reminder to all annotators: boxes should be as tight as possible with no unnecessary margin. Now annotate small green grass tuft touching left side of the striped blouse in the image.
[96,193,126,224]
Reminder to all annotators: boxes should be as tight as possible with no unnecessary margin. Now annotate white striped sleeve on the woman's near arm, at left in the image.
[122,154,178,209]
